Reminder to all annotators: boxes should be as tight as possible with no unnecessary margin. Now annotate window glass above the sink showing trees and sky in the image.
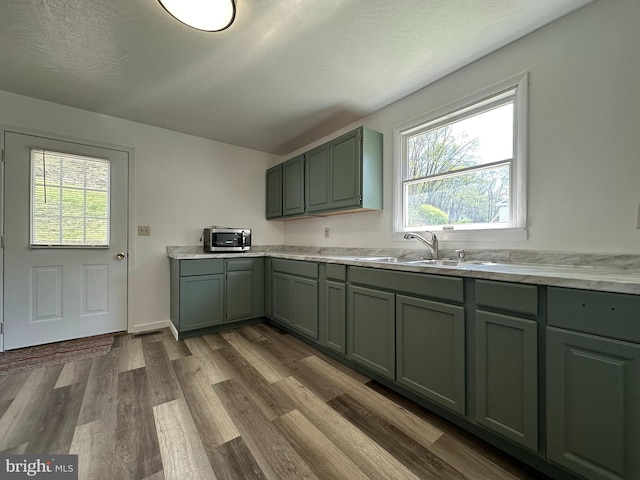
[402,90,515,229]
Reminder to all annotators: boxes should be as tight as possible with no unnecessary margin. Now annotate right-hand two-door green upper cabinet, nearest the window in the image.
[305,127,382,214]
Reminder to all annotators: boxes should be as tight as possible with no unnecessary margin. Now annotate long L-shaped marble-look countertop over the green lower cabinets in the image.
[168,247,640,295]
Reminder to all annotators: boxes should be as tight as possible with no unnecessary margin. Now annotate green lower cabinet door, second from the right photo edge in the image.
[475,310,538,451]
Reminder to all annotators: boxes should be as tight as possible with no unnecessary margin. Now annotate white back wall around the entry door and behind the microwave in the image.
[0,91,284,331]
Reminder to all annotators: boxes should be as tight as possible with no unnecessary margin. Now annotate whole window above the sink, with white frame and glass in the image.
[395,75,526,237]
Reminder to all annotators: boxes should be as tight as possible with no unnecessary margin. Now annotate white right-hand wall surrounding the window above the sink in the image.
[285,0,640,254]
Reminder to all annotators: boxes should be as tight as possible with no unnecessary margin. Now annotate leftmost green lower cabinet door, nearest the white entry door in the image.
[180,275,224,332]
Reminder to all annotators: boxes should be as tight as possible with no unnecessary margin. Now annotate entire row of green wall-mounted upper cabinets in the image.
[266,127,382,219]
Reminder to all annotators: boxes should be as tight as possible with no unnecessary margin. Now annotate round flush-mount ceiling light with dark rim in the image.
[158,0,236,32]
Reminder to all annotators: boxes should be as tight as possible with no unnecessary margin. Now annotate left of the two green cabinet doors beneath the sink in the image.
[348,286,396,380]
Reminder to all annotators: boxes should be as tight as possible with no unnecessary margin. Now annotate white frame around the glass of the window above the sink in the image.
[392,72,528,242]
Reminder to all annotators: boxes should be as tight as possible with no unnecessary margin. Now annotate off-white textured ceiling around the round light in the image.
[0,0,591,155]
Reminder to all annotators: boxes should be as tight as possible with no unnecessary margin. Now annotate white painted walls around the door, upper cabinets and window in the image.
[0,0,640,330]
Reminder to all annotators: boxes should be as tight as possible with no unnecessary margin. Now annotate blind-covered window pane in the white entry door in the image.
[30,149,110,248]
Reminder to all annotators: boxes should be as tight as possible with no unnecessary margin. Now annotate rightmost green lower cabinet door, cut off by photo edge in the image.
[547,327,640,480]
